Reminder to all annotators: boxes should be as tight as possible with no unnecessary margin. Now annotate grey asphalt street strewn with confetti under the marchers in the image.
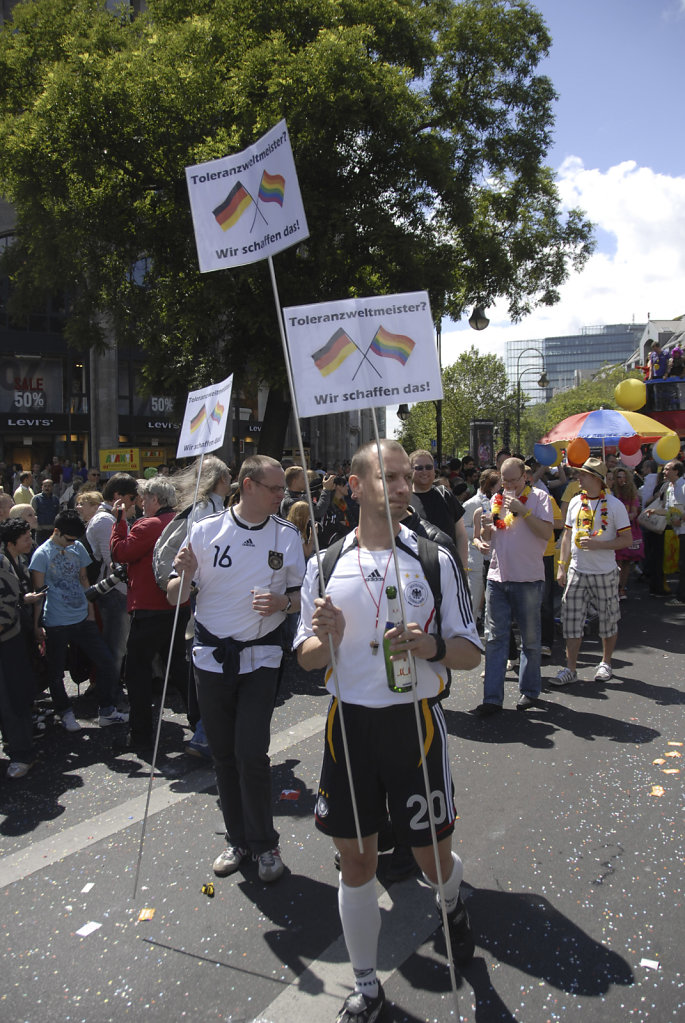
[0,582,685,1023]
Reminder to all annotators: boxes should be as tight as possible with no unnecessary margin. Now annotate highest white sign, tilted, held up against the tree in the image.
[185,121,309,273]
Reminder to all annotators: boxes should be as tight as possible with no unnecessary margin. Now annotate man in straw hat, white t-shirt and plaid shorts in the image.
[550,458,633,685]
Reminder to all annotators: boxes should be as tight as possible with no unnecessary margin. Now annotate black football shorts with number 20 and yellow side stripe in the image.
[315,698,456,846]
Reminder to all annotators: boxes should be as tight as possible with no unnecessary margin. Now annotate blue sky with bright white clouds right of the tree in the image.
[387,0,685,436]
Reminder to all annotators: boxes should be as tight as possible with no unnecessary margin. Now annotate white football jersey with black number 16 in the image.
[189,508,305,674]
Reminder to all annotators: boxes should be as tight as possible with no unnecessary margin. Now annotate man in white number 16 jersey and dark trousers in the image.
[167,455,305,882]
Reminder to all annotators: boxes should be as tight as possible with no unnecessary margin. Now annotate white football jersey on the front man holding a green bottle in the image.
[293,526,483,707]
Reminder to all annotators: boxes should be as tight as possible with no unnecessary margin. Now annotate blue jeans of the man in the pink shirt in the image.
[483,579,545,707]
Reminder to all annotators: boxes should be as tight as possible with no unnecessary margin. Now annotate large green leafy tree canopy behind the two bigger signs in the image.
[0,0,592,435]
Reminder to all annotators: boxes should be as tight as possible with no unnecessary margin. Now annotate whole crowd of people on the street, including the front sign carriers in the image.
[0,440,685,1023]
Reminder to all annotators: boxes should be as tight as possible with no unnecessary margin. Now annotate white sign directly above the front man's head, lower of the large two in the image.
[283,292,443,416]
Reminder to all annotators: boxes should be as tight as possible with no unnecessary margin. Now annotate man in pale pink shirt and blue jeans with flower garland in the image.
[473,458,554,717]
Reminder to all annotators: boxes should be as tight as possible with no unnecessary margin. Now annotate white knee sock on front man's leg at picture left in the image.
[337,878,380,998]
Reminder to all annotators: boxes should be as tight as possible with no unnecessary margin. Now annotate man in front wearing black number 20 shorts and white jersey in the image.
[295,440,482,1023]
